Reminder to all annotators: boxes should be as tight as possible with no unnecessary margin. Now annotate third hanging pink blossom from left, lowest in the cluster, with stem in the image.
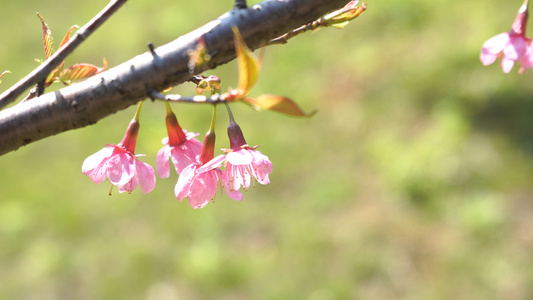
[174,107,242,209]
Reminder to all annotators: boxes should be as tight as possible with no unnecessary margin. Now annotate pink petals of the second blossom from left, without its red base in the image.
[156,130,202,178]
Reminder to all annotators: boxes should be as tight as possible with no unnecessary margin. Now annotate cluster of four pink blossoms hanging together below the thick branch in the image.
[82,103,272,208]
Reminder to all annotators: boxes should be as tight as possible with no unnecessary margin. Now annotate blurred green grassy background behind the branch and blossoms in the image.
[0,0,533,300]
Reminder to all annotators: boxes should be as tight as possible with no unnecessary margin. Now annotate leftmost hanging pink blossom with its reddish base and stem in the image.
[81,102,155,194]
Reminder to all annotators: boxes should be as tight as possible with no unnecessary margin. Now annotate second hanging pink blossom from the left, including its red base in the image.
[156,102,202,178]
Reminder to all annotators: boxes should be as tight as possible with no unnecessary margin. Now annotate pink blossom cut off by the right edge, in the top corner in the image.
[480,0,533,73]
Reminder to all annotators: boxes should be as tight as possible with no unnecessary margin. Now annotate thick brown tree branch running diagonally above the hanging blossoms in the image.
[0,0,348,155]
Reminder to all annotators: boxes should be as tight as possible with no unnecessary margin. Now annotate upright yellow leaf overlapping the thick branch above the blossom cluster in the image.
[233,26,261,97]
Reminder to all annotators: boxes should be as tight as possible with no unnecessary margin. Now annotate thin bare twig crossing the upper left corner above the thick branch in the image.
[0,0,127,109]
